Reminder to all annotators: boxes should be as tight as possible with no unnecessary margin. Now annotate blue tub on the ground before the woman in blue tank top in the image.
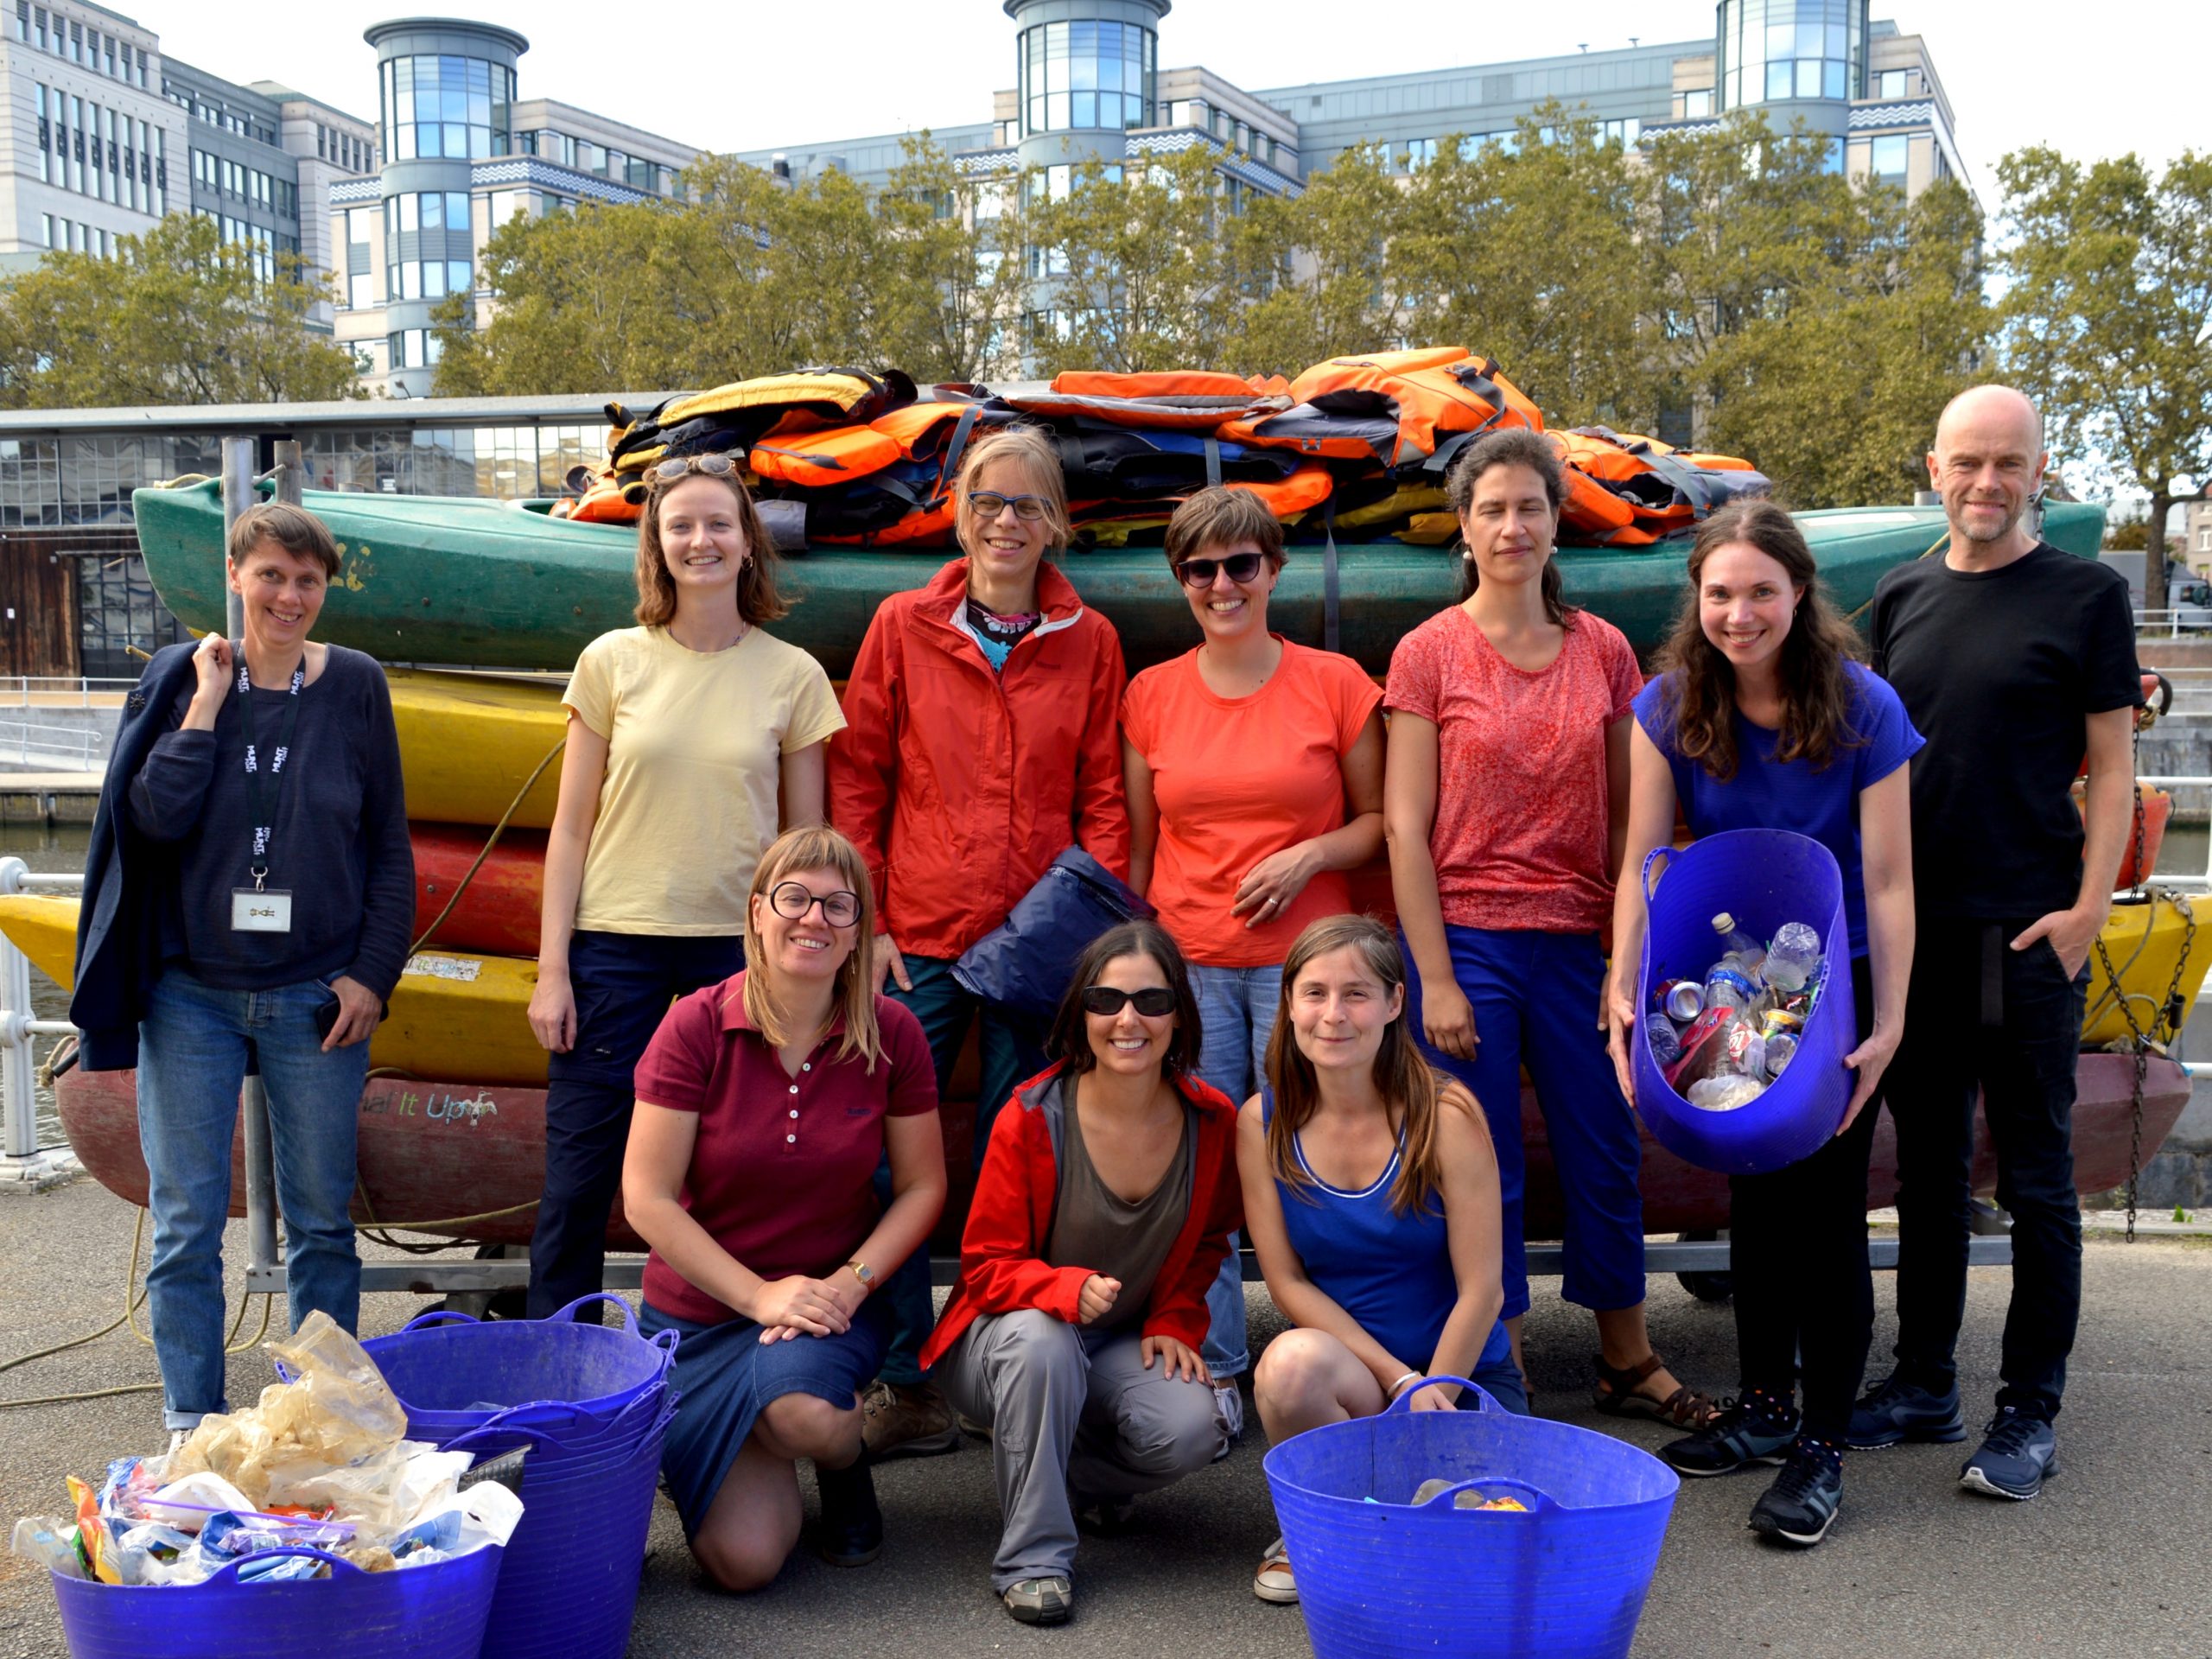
[1261,1378,1681,1659]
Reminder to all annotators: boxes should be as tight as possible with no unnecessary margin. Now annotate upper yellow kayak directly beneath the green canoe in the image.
[385,668,569,831]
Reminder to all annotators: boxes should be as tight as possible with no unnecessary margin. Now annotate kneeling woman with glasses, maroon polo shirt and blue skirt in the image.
[621,825,944,1591]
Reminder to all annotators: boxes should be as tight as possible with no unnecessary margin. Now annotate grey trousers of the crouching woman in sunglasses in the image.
[936,1307,1221,1592]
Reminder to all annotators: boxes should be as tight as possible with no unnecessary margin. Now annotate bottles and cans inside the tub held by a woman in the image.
[1643,912,1827,1113]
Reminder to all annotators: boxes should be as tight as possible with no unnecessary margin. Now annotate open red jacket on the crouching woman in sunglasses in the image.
[923,1064,1243,1370]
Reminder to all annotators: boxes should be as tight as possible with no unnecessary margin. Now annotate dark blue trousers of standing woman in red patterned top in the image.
[1407,927,1643,1319]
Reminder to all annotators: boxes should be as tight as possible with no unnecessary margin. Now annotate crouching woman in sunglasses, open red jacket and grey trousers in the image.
[923,923,1241,1624]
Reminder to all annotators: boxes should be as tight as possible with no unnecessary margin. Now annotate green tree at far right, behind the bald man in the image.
[1998,146,2212,611]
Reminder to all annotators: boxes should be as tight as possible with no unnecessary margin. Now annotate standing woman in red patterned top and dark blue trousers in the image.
[1382,429,1712,1427]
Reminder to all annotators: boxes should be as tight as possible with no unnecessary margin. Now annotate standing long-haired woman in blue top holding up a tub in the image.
[1606,500,1923,1546]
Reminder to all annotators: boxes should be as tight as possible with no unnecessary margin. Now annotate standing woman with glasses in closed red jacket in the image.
[830,429,1128,1458]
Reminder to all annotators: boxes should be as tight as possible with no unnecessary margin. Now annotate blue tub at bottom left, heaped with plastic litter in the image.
[53,1546,505,1659]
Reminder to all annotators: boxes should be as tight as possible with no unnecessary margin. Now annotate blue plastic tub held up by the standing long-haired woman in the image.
[1632,830,1858,1174]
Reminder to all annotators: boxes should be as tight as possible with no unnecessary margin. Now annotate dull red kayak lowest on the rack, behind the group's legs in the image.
[55,1053,2190,1252]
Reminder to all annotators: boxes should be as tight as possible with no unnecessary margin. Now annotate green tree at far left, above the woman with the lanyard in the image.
[0,213,363,410]
